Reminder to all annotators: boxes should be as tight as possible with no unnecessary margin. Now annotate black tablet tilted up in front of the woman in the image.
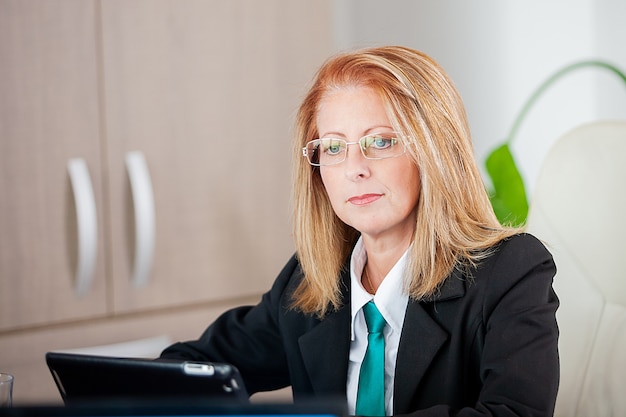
[46,352,248,404]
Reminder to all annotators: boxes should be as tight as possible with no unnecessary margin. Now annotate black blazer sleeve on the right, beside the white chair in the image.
[477,235,559,416]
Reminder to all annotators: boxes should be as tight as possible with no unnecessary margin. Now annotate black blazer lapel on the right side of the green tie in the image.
[394,272,465,413]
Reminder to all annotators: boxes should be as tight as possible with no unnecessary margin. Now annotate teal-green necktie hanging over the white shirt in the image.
[356,301,386,417]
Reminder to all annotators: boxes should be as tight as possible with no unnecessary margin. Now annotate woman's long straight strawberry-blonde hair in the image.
[293,46,520,317]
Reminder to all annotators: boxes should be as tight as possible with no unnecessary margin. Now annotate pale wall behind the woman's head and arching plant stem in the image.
[334,0,626,192]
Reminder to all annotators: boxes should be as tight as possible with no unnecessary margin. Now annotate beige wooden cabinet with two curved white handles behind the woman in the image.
[0,0,332,399]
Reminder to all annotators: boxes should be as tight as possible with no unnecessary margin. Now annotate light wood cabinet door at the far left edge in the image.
[0,0,106,330]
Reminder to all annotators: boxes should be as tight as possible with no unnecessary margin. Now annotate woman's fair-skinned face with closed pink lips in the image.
[317,87,420,243]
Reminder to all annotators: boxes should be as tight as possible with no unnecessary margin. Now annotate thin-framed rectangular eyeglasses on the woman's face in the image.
[302,132,406,167]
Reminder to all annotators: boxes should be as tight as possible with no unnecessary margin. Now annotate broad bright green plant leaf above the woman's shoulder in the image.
[485,143,528,226]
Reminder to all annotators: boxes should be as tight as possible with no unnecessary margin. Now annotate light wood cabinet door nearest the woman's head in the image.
[102,0,331,312]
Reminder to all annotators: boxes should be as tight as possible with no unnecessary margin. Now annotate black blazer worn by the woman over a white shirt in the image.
[162,234,559,417]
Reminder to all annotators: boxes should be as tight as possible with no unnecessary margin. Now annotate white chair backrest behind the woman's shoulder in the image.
[527,121,626,417]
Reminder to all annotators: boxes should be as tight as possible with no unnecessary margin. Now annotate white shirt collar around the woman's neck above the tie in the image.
[350,238,409,340]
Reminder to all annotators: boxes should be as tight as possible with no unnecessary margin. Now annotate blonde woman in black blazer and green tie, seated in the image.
[162,47,559,417]
